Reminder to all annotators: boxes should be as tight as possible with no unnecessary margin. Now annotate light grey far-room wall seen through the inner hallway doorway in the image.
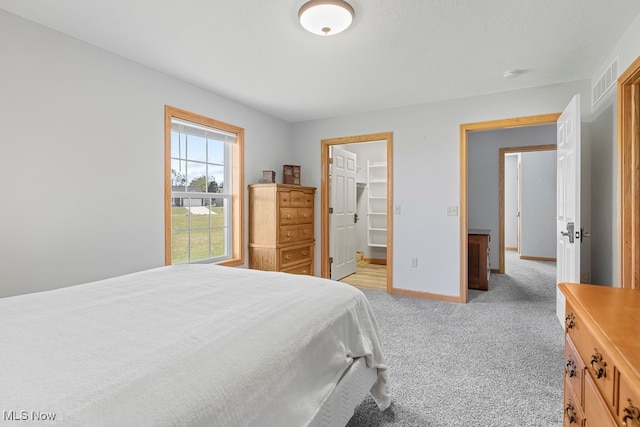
[520,150,557,259]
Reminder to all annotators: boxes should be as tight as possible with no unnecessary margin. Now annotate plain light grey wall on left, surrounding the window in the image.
[0,11,291,297]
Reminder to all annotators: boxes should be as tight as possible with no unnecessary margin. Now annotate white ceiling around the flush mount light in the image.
[0,0,640,123]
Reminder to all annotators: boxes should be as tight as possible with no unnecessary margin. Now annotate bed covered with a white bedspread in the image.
[0,264,390,427]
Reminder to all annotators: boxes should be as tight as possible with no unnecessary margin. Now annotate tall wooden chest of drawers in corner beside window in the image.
[249,184,316,276]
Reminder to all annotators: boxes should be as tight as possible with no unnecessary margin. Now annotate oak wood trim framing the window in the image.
[164,105,245,266]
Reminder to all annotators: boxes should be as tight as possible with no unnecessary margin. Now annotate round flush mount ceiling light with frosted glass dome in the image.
[298,0,354,36]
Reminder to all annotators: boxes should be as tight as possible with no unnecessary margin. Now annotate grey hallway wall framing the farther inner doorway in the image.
[467,125,556,269]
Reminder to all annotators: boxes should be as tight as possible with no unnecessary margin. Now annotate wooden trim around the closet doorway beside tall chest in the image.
[320,132,393,293]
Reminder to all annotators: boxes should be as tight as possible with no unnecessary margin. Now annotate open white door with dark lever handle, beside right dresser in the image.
[556,95,581,325]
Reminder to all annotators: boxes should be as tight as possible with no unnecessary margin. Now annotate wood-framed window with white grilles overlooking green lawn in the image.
[165,106,244,265]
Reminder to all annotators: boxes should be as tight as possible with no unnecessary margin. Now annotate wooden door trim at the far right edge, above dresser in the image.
[618,57,640,289]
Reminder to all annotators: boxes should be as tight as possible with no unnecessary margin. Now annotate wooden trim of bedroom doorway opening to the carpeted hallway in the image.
[459,113,560,303]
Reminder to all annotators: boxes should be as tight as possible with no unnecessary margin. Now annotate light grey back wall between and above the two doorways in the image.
[293,80,589,296]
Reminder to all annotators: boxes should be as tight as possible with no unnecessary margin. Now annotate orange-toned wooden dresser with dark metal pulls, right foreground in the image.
[558,283,640,427]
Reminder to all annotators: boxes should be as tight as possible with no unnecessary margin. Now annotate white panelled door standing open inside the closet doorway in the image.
[329,145,357,280]
